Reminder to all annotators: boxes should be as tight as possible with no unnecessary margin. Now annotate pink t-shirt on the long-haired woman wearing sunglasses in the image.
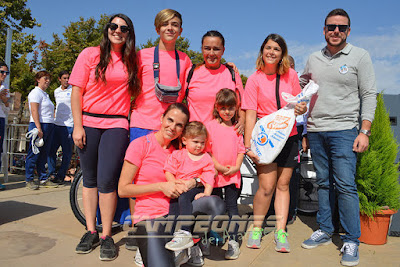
[68,47,131,129]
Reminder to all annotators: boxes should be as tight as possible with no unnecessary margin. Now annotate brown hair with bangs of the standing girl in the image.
[213,88,239,124]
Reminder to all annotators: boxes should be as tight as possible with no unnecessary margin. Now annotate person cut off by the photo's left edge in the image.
[0,62,10,190]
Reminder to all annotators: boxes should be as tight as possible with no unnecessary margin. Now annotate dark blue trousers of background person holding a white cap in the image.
[25,122,54,182]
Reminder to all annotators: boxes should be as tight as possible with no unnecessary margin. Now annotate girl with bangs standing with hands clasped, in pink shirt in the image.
[206,88,245,259]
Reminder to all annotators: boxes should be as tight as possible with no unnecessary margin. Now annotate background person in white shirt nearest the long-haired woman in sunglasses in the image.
[47,70,74,184]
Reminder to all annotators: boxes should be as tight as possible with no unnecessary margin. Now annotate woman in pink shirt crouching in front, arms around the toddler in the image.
[118,103,192,267]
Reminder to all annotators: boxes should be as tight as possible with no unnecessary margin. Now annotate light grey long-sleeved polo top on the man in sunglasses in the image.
[300,44,376,132]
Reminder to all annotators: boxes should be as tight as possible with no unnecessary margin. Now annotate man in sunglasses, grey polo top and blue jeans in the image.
[300,9,376,266]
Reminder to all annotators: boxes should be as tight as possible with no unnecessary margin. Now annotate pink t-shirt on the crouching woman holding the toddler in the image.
[125,133,173,223]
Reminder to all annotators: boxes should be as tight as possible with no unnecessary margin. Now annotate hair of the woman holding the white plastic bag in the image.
[256,33,290,75]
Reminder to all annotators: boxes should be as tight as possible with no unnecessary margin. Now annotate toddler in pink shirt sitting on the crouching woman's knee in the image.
[164,121,215,251]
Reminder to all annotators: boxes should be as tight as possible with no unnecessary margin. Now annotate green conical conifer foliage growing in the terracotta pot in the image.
[356,93,400,217]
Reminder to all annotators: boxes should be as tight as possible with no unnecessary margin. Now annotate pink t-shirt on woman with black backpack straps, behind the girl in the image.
[181,65,243,124]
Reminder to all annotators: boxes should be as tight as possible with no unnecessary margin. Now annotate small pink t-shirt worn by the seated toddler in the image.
[164,148,215,186]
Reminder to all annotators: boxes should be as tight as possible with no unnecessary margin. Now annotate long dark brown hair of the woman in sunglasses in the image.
[96,14,141,98]
